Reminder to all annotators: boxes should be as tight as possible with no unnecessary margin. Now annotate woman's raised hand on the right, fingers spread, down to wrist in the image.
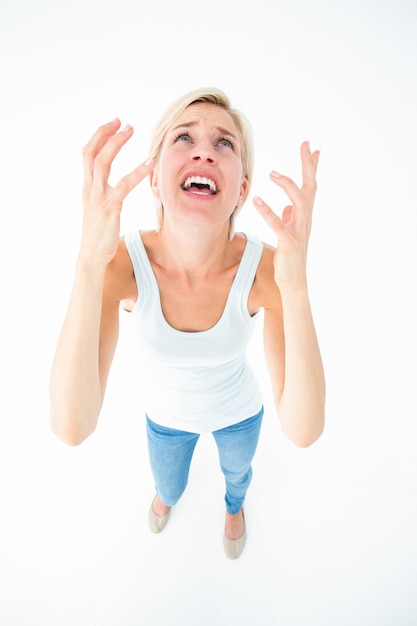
[254,141,320,292]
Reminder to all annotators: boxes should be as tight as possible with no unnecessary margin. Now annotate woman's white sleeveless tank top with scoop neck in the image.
[125,231,263,433]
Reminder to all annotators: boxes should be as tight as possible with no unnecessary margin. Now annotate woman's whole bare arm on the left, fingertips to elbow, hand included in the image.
[50,120,152,445]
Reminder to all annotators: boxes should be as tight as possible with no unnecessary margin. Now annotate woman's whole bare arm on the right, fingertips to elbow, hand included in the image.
[255,143,325,447]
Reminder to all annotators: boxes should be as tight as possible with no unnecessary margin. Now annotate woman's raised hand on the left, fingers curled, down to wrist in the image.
[80,119,155,266]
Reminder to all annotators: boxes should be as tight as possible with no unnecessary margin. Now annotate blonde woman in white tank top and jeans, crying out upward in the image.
[50,89,325,558]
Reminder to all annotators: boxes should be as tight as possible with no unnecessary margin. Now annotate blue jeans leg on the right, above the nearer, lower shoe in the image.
[213,407,264,514]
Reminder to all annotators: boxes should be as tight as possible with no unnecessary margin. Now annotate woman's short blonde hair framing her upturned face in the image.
[150,87,254,239]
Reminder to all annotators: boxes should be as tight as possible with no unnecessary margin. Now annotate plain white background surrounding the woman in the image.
[0,0,417,626]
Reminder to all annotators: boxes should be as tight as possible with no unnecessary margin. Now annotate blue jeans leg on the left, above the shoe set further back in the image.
[146,416,199,506]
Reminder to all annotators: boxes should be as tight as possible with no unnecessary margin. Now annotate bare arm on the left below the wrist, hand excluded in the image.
[50,254,119,445]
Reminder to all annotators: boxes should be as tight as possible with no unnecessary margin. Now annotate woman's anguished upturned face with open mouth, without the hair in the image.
[151,103,248,230]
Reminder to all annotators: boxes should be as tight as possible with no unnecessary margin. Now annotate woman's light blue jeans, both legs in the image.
[146,407,264,515]
